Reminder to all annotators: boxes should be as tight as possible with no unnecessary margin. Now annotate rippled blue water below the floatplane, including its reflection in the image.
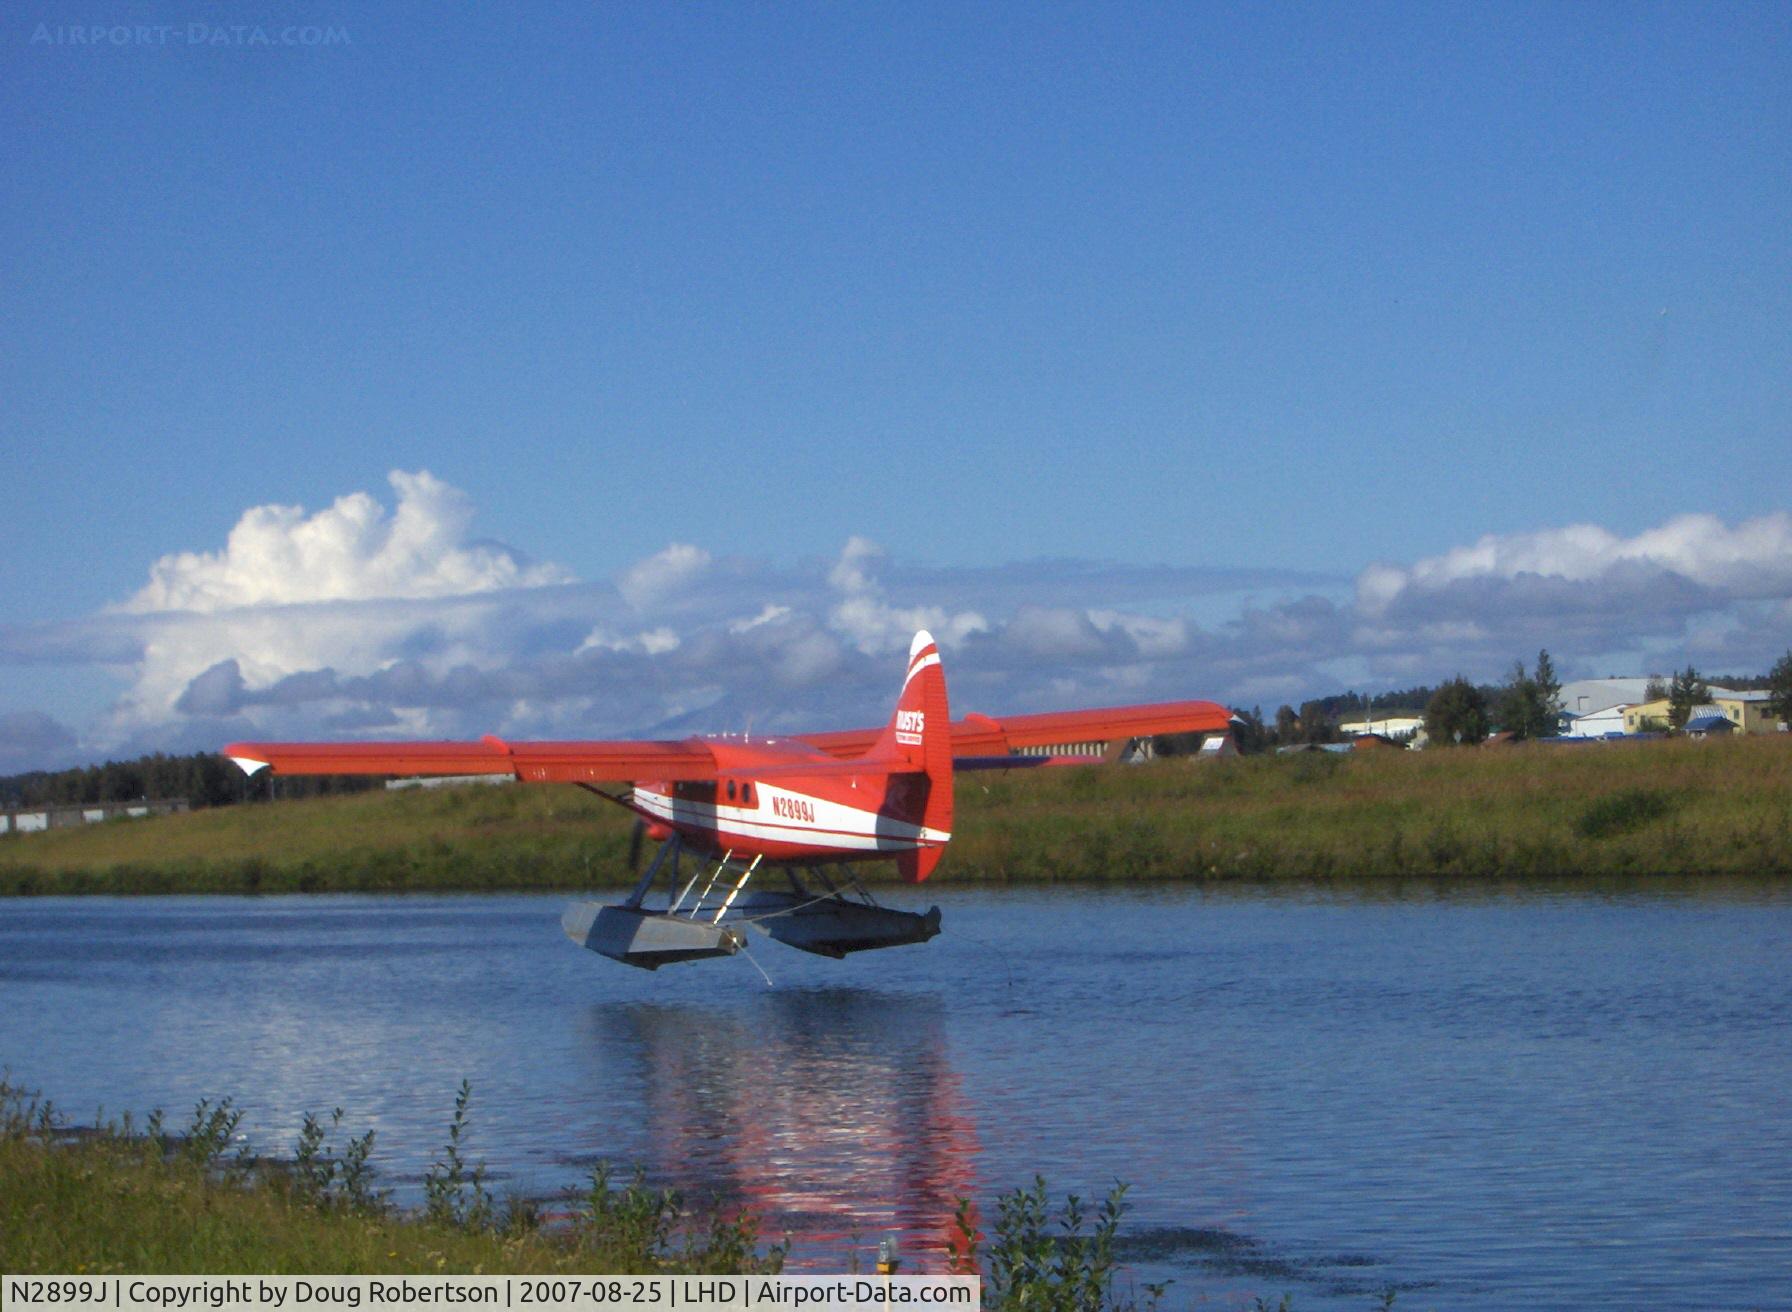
[0,885,1792,1310]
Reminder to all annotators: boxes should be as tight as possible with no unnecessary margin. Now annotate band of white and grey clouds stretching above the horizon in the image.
[0,487,1792,774]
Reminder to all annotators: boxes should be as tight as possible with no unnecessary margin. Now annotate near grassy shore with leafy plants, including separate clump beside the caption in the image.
[0,1079,1161,1312]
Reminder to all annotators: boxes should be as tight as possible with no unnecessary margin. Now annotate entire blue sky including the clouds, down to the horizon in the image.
[0,4,1792,769]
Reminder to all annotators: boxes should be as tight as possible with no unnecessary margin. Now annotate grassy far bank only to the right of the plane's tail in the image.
[946,738,1792,882]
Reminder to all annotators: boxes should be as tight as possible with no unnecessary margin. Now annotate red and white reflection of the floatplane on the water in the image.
[590,989,978,1273]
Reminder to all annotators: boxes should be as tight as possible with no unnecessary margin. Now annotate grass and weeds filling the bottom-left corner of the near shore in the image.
[0,1081,783,1274]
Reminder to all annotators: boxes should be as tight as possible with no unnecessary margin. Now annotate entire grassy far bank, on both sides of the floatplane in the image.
[0,735,1792,894]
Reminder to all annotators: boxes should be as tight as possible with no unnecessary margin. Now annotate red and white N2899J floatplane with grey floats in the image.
[224,631,1231,966]
